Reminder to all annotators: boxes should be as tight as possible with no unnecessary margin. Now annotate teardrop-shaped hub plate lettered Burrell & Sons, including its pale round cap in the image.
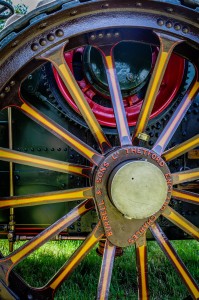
[94,147,172,247]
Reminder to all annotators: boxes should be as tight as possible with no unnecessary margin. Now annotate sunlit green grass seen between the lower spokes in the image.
[0,240,199,300]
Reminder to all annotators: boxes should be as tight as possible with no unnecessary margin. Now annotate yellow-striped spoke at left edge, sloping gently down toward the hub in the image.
[0,147,92,177]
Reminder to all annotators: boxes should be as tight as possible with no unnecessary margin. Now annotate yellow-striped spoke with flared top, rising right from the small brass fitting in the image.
[133,33,182,142]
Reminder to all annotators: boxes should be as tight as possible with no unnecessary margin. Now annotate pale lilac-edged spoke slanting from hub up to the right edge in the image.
[152,78,199,155]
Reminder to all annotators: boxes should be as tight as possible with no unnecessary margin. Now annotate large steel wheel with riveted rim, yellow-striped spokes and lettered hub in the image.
[0,1,199,299]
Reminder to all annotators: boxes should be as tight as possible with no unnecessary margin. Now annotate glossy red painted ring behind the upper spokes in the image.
[53,47,185,127]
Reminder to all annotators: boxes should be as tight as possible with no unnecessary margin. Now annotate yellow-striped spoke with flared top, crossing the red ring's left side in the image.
[38,45,111,152]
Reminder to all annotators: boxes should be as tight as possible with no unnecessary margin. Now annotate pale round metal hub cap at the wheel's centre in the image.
[110,161,168,219]
